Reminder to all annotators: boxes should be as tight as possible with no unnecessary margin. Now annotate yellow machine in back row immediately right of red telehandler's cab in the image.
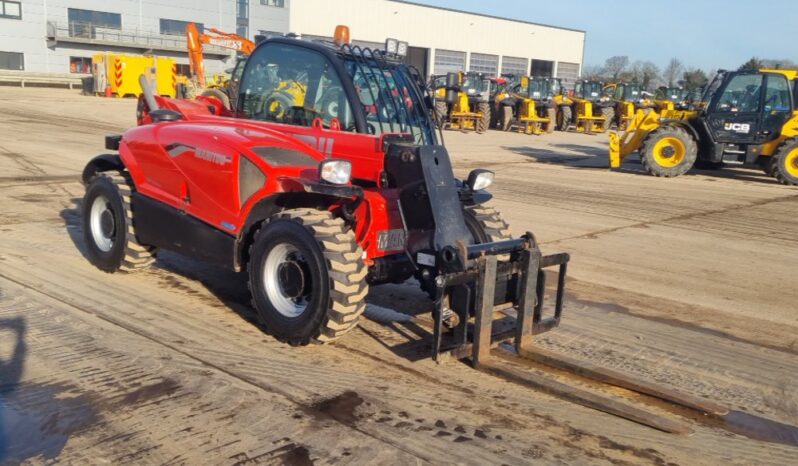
[432,72,491,133]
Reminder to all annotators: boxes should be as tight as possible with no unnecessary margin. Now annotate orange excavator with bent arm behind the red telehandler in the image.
[186,23,255,108]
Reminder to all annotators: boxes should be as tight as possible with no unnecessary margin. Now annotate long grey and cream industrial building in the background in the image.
[0,0,585,82]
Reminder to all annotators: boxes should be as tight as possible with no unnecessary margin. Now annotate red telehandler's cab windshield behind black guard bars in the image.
[342,46,437,145]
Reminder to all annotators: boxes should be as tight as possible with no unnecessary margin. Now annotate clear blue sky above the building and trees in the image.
[413,0,798,70]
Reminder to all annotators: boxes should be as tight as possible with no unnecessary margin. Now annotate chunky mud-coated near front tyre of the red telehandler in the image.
[247,209,369,345]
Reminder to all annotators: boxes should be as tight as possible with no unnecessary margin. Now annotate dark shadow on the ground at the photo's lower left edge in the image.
[0,314,27,464]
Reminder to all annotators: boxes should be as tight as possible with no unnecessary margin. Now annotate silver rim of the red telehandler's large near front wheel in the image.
[263,243,313,318]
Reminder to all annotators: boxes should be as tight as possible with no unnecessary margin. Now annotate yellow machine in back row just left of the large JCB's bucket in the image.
[555,80,613,134]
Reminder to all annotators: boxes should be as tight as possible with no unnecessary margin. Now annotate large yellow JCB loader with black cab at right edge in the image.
[609,70,798,185]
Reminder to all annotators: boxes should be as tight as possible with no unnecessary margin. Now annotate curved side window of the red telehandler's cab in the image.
[238,44,355,131]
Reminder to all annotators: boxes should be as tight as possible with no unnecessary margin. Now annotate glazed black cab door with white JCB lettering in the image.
[707,72,765,144]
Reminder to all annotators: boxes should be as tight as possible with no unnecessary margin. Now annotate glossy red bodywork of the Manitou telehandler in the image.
[132,97,410,263]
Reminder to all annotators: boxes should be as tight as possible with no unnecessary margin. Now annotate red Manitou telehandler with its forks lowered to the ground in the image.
[82,27,725,432]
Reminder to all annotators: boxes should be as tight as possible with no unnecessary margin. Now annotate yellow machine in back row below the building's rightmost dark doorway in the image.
[499,76,562,135]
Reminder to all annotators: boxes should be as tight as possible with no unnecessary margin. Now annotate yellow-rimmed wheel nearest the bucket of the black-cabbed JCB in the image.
[640,126,698,178]
